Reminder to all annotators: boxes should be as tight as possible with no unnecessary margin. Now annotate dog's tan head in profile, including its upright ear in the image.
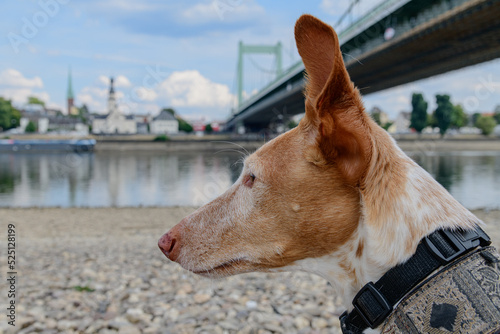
[160,15,382,276]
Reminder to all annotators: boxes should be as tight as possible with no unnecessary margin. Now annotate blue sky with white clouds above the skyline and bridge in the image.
[0,0,500,120]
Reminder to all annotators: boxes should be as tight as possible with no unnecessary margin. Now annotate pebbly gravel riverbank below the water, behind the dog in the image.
[0,207,500,334]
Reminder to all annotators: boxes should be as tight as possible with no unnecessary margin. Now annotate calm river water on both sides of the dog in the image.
[0,151,500,209]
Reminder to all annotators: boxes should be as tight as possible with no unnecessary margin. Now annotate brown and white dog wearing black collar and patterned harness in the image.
[158,15,500,333]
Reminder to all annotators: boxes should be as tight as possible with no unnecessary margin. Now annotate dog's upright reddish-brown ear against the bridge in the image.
[295,15,372,185]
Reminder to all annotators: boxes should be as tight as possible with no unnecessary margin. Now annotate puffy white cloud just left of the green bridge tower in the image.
[159,70,234,108]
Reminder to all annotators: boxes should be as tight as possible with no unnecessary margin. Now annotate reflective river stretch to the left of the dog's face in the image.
[0,153,241,207]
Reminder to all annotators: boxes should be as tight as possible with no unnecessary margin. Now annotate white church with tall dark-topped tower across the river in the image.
[92,78,137,134]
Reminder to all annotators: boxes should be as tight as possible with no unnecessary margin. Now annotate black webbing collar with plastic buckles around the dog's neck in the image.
[340,227,491,334]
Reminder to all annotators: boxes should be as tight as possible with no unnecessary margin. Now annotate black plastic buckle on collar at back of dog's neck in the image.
[423,227,491,265]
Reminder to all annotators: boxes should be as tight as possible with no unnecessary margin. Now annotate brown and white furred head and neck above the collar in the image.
[159,15,481,332]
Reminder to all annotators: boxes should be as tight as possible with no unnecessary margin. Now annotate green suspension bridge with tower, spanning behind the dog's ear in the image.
[226,0,500,132]
